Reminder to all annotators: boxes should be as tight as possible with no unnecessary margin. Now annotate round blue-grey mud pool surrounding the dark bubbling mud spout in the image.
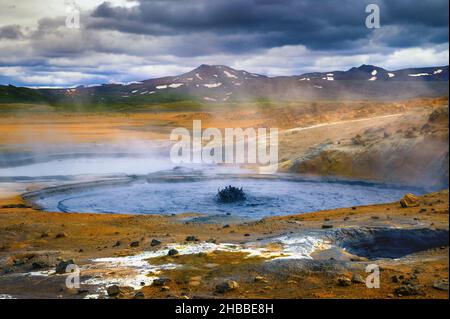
[33,169,426,219]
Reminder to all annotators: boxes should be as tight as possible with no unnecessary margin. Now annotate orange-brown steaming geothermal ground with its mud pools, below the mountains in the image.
[0,98,448,299]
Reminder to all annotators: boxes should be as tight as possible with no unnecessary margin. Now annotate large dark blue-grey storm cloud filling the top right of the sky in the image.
[89,0,448,52]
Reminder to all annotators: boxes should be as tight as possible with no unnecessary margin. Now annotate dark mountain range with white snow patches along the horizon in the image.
[0,65,449,107]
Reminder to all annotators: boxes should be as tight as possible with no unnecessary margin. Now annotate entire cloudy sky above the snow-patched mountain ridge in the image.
[0,0,449,87]
